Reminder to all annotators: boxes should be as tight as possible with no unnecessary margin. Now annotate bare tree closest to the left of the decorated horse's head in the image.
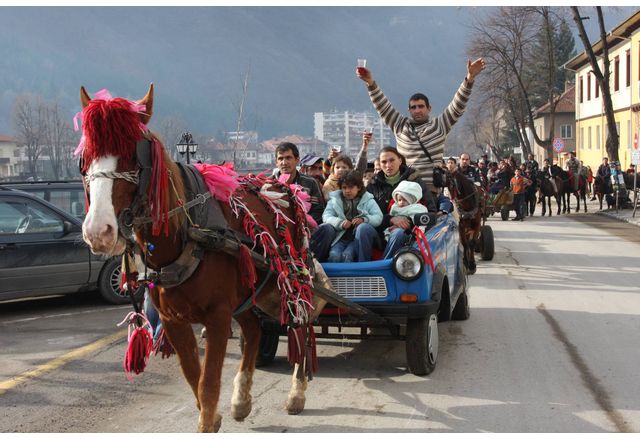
[44,101,74,180]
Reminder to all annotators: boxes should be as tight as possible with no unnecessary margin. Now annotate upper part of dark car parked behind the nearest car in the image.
[0,180,86,219]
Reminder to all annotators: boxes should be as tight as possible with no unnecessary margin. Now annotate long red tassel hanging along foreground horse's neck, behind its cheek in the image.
[149,137,169,236]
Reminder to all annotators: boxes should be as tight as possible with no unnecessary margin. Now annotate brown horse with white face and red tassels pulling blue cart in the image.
[78,84,330,432]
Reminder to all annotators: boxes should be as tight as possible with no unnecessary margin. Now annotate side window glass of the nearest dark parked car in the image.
[0,200,64,235]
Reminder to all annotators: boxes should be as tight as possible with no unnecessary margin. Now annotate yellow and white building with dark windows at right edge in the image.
[565,11,640,172]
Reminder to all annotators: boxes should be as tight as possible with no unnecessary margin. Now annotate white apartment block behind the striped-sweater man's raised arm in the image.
[313,110,395,157]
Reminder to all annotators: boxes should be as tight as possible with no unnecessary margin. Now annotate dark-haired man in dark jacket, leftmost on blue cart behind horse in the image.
[273,142,325,225]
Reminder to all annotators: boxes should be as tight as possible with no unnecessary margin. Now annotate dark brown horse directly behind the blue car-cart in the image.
[446,168,485,274]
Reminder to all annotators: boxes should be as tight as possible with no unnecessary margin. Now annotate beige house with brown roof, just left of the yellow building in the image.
[530,84,576,167]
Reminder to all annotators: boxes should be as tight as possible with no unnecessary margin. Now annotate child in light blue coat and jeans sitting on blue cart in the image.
[322,171,382,262]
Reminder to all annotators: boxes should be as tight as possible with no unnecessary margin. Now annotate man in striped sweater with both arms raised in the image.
[356,58,485,189]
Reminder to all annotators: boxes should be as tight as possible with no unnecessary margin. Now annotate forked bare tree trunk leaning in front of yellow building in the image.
[571,6,620,161]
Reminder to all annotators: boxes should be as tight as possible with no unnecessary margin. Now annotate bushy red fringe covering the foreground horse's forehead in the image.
[82,98,142,172]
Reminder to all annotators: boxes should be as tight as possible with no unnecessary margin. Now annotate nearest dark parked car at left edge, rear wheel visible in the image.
[0,185,135,304]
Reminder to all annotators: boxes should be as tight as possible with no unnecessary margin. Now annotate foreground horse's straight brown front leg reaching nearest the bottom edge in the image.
[198,308,231,433]
